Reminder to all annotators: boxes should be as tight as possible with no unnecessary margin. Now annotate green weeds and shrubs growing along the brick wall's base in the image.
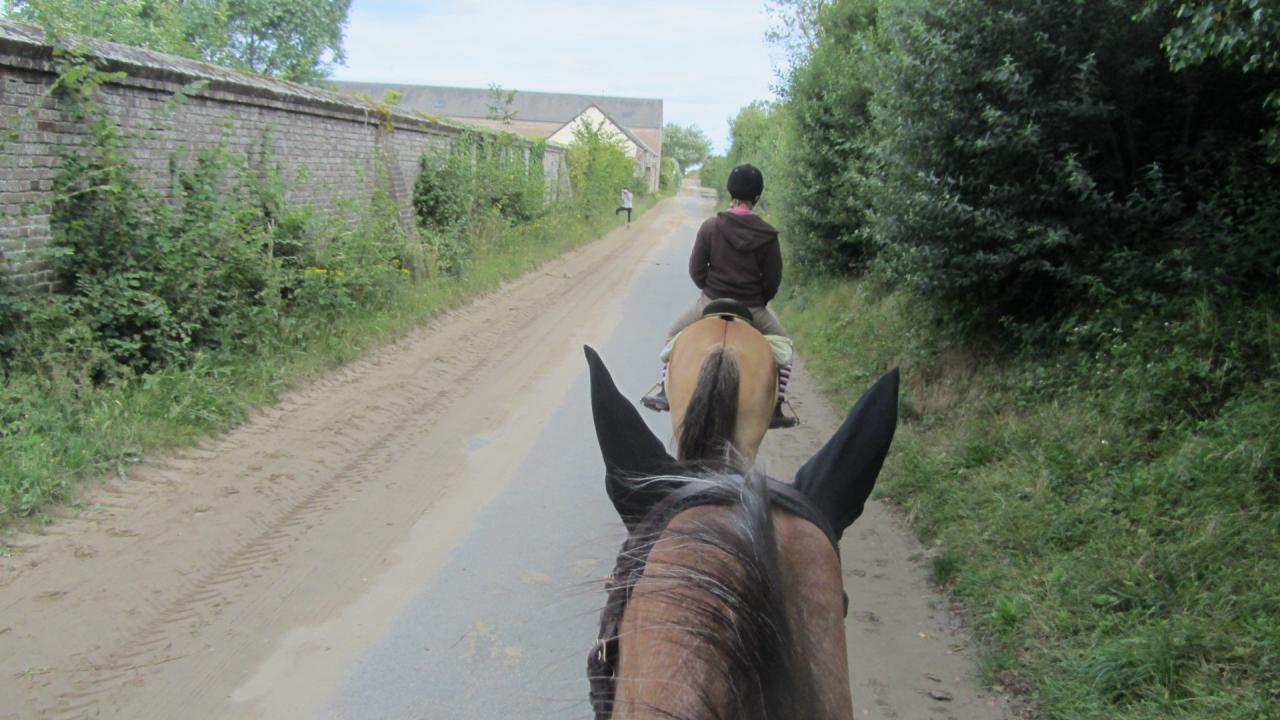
[0,56,652,524]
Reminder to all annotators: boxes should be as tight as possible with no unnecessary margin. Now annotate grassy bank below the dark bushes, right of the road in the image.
[782,272,1280,720]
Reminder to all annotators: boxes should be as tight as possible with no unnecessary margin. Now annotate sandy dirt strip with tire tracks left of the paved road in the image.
[0,201,682,719]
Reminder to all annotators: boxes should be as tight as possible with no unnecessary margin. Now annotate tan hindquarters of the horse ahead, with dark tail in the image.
[666,300,778,469]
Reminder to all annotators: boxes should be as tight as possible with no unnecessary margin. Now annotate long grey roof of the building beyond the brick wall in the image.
[333,82,662,129]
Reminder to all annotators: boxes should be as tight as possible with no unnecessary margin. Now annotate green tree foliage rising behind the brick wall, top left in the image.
[5,0,351,82]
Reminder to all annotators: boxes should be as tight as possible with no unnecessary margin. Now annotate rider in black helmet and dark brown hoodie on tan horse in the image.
[641,165,796,428]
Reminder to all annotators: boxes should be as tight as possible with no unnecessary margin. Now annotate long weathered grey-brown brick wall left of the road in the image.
[0,20,568,288]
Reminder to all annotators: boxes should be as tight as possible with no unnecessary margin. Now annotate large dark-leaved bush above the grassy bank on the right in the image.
[873,0,1280,336]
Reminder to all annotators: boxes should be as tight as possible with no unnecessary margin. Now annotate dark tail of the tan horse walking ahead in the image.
[680,346,740,462]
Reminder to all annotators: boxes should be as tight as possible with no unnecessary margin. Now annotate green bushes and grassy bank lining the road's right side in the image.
[742,0,1280,719]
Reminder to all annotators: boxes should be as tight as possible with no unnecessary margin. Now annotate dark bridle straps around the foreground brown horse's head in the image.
[586,478,849,720]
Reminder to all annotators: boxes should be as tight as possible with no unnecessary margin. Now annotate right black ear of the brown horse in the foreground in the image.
[795,368,899,537]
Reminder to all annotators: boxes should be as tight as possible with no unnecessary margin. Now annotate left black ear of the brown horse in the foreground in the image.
[582,346,680,529]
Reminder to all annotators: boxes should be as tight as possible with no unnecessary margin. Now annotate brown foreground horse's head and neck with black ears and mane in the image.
[586,347,899,720]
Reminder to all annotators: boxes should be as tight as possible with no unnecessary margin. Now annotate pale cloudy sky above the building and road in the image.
[333,0,776,152]
